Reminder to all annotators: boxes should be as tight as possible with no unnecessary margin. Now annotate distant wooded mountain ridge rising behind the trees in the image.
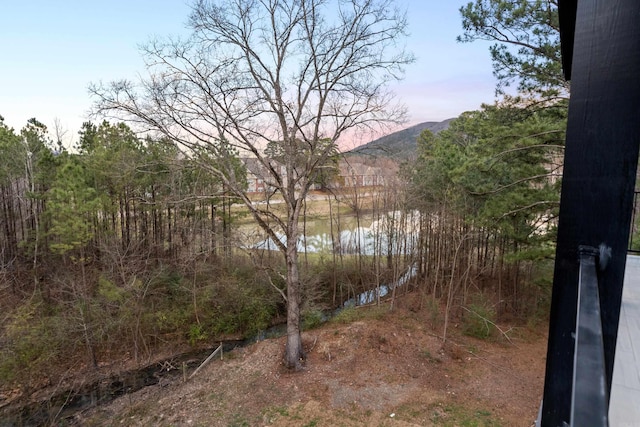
[348,119,453,160]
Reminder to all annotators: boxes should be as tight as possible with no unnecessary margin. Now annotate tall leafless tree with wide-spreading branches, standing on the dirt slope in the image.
[90,0,413,368]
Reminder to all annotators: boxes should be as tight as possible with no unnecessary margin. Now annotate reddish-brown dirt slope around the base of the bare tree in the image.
[76,298,546,427]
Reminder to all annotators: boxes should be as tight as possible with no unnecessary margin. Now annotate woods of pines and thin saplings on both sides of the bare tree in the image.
[0,105,565,402]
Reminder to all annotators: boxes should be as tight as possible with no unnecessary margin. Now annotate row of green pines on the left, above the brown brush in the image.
[0,119,243,278]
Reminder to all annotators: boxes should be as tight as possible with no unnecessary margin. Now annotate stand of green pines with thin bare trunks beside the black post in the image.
[404,99,566,332]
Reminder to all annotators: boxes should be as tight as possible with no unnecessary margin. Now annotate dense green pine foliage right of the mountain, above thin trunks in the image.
[411,103,566,259]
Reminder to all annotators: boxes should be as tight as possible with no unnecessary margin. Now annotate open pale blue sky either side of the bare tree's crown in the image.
[0,0,495,145]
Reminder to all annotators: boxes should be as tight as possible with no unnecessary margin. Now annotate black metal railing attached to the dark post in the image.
[571,246,609,427]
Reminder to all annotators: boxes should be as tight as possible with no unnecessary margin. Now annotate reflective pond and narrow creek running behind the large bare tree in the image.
[5,212,419,427]
